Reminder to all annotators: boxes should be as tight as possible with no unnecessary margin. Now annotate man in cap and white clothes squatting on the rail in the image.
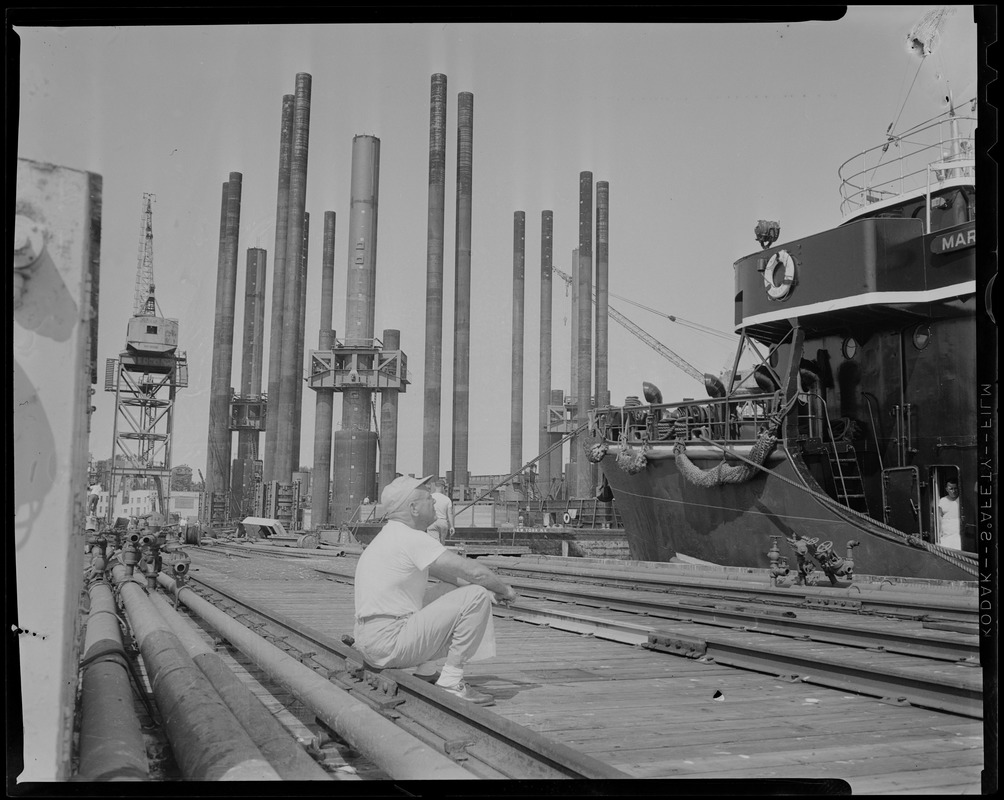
[352,477,516,706]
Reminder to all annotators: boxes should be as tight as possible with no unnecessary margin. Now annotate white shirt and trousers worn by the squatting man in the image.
[352,520,495,669]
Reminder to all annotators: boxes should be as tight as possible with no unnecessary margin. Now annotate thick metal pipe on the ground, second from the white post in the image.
[112,566,279,781]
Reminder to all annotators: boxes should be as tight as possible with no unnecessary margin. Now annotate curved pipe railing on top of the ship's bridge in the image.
[837,115,977,217]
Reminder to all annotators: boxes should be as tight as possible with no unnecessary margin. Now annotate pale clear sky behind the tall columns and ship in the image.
[14,6,978,475]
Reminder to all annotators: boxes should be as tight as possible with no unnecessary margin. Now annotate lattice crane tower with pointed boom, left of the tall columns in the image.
[104,194,188,524]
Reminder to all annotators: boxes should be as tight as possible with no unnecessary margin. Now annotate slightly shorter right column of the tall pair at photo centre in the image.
[453,91,474,497]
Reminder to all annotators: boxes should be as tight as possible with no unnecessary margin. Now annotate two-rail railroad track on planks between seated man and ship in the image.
[315,565,983,719]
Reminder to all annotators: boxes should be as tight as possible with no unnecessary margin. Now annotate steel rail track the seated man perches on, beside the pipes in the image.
[191,577,631,780]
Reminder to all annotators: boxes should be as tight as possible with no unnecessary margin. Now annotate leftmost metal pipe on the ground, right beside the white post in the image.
[77,582,150,781]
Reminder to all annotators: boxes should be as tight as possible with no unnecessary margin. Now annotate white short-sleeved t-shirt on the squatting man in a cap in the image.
[355,520,446,619]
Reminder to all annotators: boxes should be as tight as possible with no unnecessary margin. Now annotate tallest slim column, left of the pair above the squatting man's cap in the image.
[422,73,447,475]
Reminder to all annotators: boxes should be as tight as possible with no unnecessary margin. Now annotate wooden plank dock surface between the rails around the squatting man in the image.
[186,551,984,794]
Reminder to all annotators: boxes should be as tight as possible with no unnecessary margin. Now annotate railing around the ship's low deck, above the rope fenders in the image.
[600,392,781,445]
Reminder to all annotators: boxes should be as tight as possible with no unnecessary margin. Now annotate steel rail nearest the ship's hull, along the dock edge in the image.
[482,558,978,623]
